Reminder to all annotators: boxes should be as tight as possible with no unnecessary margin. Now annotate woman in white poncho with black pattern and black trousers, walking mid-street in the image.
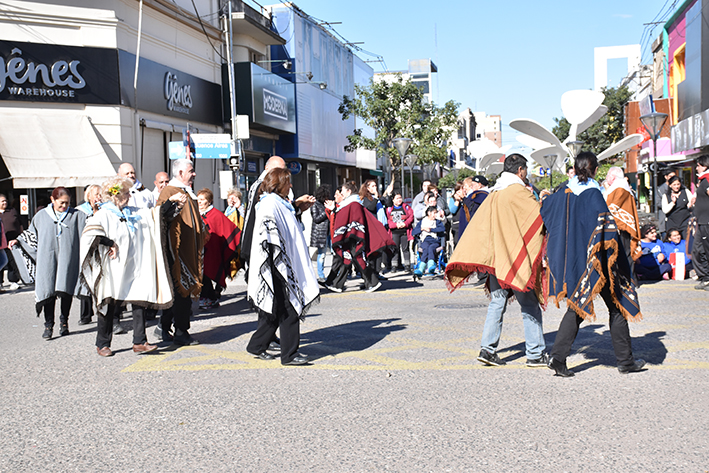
[246,168,320,365]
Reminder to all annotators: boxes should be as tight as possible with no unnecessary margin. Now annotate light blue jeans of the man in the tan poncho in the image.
[480,275,546,360]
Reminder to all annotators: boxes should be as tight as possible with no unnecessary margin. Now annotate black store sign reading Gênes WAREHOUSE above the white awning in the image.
[0,41,120,104]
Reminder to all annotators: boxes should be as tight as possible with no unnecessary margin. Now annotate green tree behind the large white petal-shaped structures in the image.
[552,86,633,155]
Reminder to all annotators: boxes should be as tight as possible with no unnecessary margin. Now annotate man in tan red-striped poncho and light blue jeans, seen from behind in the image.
[446,154,548,367]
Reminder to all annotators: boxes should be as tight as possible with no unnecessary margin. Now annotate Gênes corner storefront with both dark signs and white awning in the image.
[0,41,223,213]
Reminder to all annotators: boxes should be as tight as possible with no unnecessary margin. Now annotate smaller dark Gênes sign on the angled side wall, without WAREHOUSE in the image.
[119,50,224,126]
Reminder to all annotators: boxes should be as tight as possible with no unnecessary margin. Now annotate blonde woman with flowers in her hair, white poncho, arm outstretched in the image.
[81,177,186,356]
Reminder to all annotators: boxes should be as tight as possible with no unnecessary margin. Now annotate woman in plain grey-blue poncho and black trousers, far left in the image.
[9,187,86,340]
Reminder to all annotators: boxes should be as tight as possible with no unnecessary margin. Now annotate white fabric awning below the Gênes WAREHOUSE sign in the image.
[0,107,116,188]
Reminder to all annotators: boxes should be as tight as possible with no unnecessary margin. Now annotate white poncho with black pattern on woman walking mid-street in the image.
[247,194,320,320]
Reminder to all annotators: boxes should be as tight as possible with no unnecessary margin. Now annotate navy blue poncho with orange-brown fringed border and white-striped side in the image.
[541,187,642,320]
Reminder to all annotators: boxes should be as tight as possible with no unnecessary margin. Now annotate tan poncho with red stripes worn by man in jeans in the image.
[445,183,544,301]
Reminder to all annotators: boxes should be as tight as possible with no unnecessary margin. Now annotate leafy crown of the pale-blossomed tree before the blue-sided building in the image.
[338,74,459,189]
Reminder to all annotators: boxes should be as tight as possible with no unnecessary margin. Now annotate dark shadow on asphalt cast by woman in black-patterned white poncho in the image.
[300,319,406,360]
